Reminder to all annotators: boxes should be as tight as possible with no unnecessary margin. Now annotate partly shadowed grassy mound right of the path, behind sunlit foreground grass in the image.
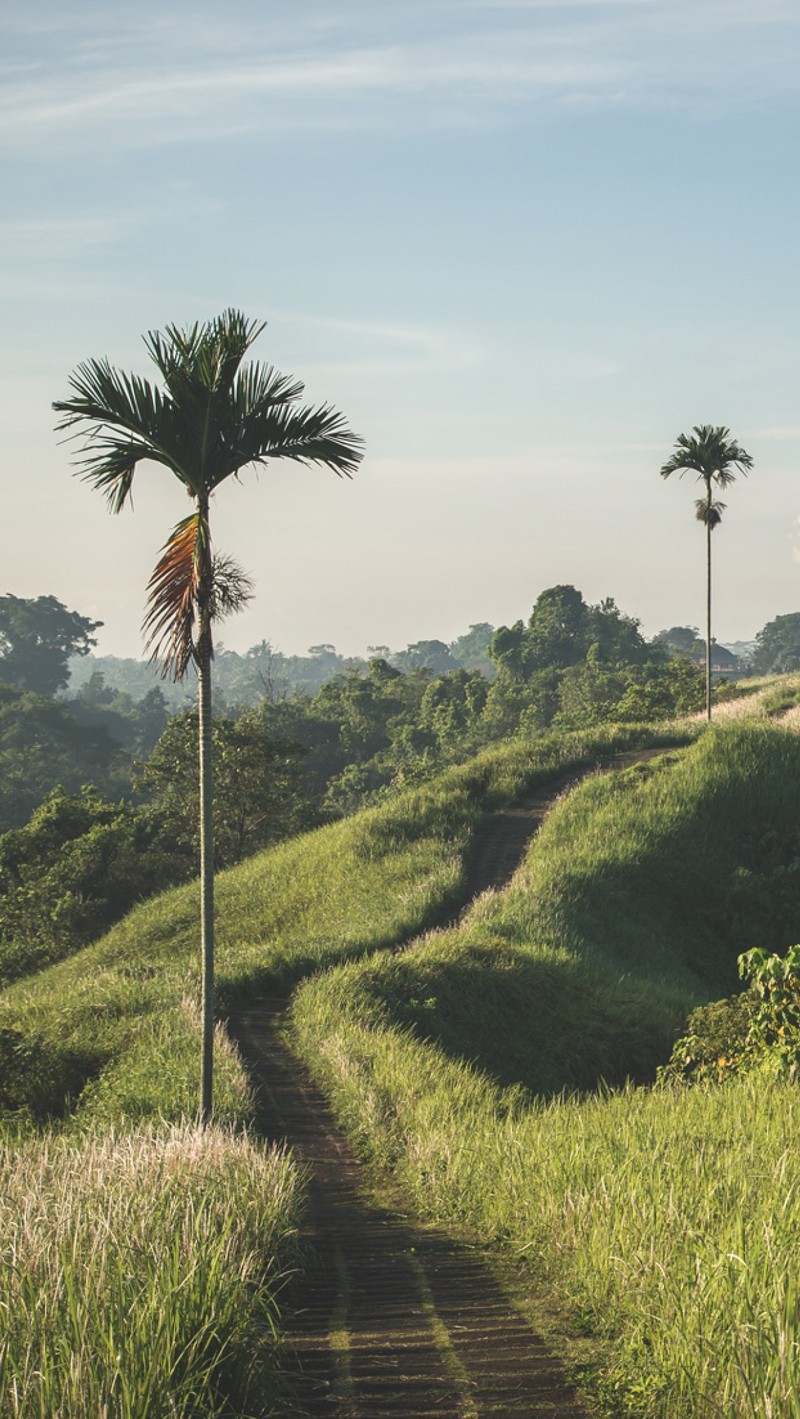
[319,724,800,1094]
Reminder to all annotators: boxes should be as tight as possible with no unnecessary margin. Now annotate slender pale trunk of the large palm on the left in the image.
[197,536,214,1127]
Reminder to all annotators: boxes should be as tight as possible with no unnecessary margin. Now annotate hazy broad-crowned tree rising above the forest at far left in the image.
[0,595,102,695]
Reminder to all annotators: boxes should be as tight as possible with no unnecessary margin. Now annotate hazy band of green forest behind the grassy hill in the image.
[0,585,800,983]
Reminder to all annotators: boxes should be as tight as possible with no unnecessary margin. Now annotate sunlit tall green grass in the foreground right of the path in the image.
[294,966,800,1419]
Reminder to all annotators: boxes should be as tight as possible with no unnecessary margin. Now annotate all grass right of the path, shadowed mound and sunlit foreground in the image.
[292,724,800,1419]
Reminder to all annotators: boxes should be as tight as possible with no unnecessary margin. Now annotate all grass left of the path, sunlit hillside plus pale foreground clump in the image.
[0,728,694,1419]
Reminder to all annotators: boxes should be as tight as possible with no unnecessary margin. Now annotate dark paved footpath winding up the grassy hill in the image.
[230,746,665,1419]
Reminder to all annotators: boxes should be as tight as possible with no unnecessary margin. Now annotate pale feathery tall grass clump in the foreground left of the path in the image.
[0,1125,298,1419]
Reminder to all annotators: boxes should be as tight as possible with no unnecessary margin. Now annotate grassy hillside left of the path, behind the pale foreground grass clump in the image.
[0,727,686,1127]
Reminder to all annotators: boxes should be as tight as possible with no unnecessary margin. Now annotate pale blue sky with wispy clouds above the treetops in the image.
[0,0,800,656]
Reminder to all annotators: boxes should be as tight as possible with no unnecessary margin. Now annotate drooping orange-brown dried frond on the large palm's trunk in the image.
[142,511,210,680]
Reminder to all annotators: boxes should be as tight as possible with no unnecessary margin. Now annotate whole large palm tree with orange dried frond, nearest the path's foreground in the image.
[52,311,363,1122]
